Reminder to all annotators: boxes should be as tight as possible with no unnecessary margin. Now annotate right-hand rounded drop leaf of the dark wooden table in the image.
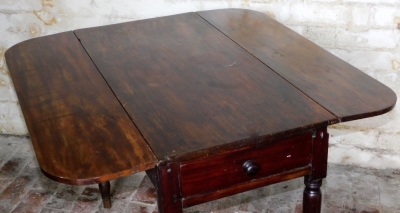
[198,9,397,122]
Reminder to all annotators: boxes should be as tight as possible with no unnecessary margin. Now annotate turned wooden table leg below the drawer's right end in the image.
[303,176,322,213]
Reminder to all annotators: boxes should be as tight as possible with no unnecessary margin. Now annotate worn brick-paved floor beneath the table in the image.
[0,135,400,213]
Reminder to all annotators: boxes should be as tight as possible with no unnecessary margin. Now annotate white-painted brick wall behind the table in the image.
[0,0,400,169]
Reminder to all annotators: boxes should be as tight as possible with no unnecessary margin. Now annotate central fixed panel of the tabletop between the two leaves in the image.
[75,13,336,160]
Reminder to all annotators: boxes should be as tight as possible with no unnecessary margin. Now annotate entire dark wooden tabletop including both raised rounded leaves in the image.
[6,9,396,184]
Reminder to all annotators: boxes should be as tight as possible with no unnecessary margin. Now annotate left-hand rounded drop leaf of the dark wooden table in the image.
[5,32,156,184]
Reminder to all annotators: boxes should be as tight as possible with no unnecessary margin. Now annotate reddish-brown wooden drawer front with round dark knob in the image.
[181,132,312,198]
